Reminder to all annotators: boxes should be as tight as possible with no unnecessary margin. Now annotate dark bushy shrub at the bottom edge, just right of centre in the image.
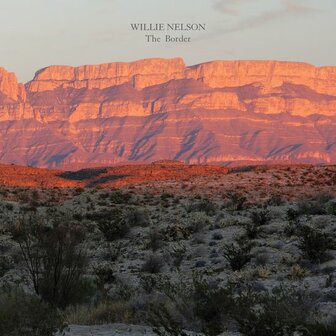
[149,273,233,336]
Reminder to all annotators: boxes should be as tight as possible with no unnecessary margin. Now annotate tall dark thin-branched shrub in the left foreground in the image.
[12,214,88,307]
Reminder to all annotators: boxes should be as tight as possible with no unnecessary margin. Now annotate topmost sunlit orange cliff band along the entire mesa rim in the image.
[27,58,336,95]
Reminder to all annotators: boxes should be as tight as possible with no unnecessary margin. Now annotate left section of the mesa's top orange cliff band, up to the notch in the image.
[27,58,185,92]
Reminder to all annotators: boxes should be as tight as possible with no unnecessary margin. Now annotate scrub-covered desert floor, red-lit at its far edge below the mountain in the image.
[0,161,336,336]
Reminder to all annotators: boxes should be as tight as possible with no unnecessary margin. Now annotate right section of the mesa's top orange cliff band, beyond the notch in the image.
[186,61,336,95]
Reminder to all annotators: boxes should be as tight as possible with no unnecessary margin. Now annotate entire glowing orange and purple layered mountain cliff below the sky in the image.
[0,58,336,168]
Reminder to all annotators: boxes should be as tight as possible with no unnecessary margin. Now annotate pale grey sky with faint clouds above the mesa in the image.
[0,0,336,82]
